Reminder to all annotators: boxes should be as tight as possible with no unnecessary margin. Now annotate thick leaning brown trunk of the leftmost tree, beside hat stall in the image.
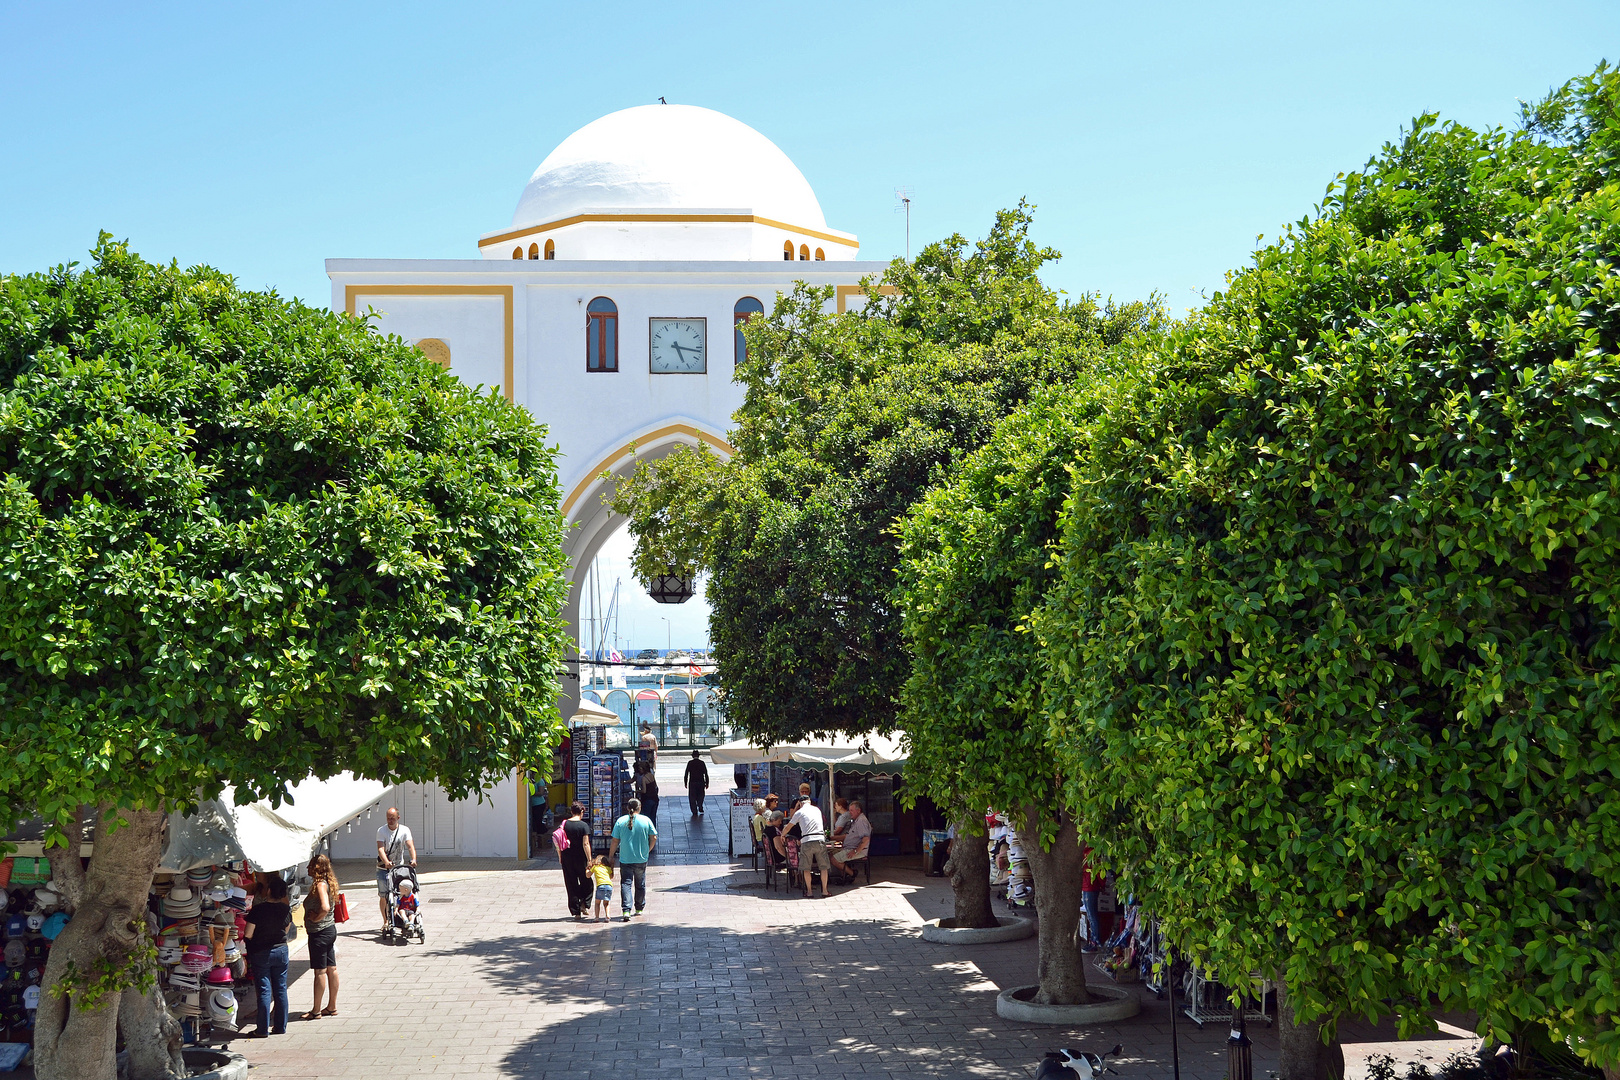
[34,806,164,1080]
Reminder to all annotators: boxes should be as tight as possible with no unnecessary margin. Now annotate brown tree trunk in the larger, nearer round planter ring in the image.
[1021,803,1092,1006]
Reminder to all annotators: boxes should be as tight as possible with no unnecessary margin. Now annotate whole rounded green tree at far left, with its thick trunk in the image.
[0,236,564,1080]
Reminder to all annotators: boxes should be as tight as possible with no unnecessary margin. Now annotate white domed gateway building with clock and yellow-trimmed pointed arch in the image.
[326,105,885,858]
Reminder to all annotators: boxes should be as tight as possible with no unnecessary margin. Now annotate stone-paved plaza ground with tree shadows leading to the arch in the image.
[233,769,1474,1080]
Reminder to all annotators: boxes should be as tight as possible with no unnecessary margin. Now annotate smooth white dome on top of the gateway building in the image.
[512,105,826,230]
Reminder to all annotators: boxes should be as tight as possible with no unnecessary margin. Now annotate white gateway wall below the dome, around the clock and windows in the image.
[327,257,886,858]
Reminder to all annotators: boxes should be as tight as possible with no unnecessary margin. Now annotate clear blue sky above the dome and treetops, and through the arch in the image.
[0,0,1620,648]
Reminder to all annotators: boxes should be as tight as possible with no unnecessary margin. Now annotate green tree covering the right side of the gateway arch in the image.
[614,206,1157,997]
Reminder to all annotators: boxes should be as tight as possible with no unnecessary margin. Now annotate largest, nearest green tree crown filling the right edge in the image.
[1034,68,1620,1080]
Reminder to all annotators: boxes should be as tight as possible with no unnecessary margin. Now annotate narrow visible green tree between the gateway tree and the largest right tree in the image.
[896,383,1127,1004]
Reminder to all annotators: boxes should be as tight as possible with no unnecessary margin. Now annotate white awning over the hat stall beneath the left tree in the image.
[159,772,389,873]
